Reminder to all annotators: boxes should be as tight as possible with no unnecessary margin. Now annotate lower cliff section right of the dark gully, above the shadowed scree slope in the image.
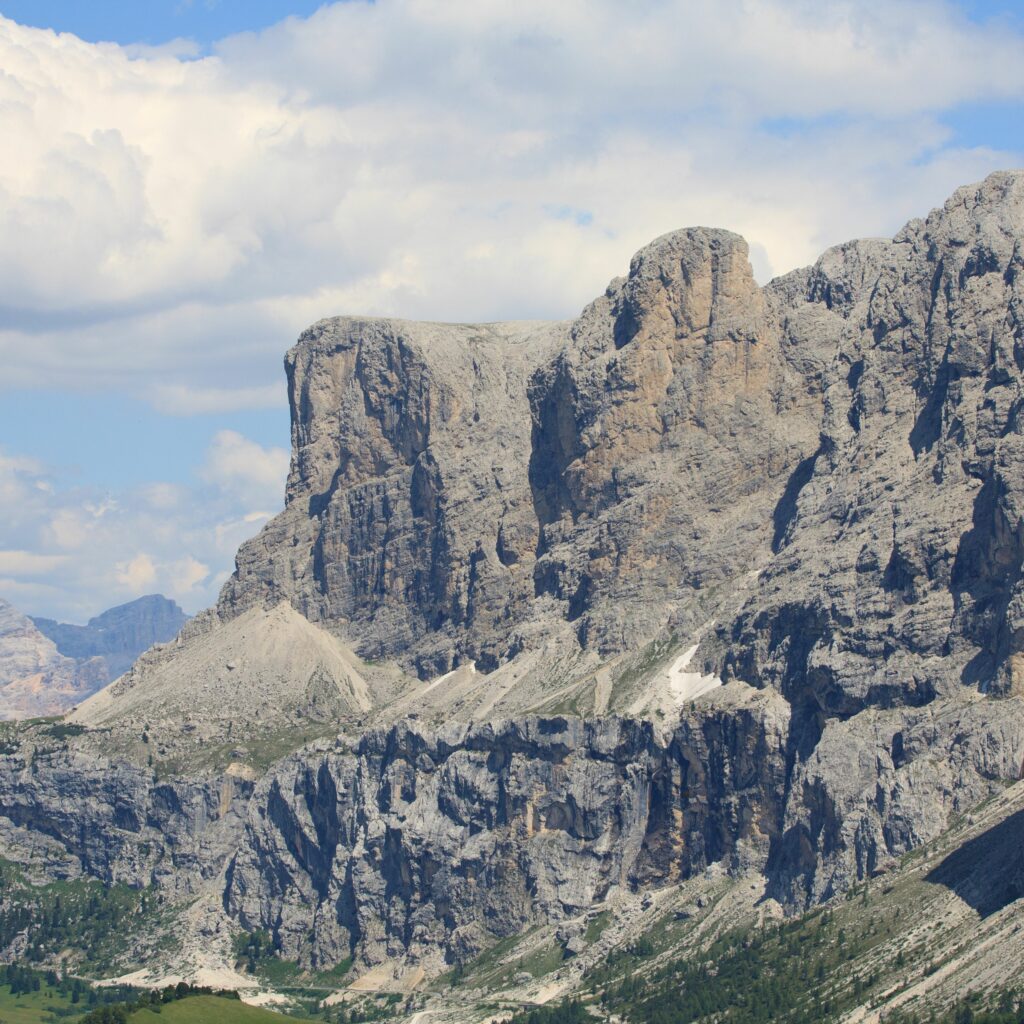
[768,698,1024,907]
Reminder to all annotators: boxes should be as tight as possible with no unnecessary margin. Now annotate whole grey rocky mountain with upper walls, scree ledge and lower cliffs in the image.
[0,172,1024,1024]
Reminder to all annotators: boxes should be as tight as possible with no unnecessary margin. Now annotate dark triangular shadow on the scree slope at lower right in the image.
[925,811,1024,918]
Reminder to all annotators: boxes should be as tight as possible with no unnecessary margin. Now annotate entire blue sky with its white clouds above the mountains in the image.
[0,0,1024,621]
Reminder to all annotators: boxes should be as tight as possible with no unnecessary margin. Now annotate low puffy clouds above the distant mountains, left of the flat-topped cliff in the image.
[0,431,288,622]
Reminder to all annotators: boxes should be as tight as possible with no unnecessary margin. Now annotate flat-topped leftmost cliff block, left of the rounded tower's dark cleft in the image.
[219,318,560,676]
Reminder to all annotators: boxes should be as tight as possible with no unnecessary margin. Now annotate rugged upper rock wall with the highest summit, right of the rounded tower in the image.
[718,173,1024,729]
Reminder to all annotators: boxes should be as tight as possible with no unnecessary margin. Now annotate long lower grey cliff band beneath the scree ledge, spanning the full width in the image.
[0,683,1024,971]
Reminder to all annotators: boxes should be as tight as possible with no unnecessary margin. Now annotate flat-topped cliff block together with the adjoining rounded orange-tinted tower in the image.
[219,228,835,676]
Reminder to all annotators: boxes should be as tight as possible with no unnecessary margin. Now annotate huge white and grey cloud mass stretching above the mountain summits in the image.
[0,0,1024,399]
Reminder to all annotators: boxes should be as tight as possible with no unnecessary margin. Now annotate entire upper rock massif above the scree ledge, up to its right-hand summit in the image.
[81,172,1024,741]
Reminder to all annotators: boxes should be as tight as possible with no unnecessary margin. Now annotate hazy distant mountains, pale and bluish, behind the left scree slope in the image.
[0,595,187,720]
